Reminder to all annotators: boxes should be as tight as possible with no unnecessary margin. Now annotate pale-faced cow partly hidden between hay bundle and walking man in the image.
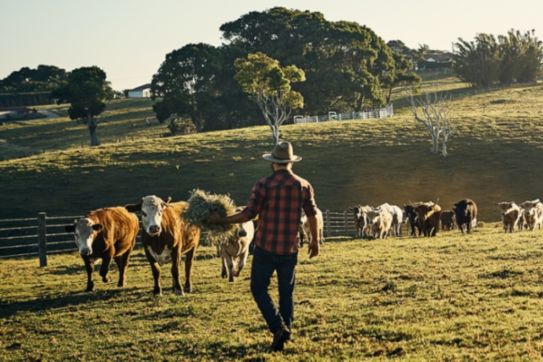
[218,209,255,282]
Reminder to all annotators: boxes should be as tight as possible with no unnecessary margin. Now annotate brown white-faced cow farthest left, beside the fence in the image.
[65,207,139,292]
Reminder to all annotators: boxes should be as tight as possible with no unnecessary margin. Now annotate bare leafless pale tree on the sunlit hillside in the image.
[411,93,452,157]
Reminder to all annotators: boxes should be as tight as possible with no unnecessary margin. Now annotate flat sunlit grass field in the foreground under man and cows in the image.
[0,224,543,361]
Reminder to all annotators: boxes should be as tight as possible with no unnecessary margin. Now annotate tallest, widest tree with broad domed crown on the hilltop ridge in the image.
[221,7,393,113]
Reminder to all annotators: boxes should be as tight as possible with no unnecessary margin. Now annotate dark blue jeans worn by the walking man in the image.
[251,247,298,333]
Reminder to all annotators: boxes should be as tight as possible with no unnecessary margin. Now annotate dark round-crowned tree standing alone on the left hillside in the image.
[53,66,113,146]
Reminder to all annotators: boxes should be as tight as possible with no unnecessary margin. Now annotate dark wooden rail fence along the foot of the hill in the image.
[0,210,362,267]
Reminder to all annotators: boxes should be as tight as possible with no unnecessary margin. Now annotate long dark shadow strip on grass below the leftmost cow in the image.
[0,288,135,318]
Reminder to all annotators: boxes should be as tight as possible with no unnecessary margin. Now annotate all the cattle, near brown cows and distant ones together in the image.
[66,195,543,295]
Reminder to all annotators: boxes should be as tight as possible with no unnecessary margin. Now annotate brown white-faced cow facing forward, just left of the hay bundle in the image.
[125,195,200,296]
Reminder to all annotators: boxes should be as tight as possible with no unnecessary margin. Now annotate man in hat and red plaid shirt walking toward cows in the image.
[208,141,320,351]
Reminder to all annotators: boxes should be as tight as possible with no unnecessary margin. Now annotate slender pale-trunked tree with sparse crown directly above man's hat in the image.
[235,53,305,144]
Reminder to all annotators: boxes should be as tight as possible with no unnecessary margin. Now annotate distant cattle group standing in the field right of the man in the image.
[352,199,543,239]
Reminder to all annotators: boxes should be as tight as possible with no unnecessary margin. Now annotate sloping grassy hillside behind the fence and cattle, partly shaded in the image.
[0,79,543,221]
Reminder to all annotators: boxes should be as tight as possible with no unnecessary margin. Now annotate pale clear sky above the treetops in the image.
[0,0,543,90]
